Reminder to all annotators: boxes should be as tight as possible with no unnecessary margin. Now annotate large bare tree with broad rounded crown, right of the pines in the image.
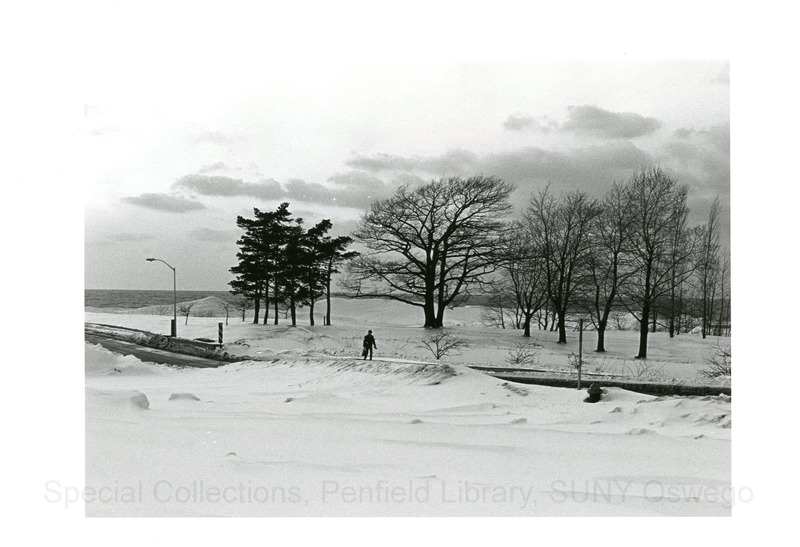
[348,176,514,328]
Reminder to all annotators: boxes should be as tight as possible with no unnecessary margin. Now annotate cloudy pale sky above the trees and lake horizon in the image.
[80,7,730,290]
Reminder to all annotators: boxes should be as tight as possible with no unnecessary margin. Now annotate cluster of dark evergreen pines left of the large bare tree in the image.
[230,203,358,325]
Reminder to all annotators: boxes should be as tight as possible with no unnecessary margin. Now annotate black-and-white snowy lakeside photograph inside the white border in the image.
[83,47,739,516]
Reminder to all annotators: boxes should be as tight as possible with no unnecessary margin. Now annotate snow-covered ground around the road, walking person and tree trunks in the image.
[86,300,732,516]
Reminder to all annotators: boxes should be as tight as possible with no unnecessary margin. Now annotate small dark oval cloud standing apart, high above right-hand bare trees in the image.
[561,105,661,139]
